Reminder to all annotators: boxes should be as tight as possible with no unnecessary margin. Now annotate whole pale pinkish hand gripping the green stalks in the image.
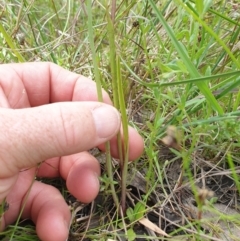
[0,62,143,241]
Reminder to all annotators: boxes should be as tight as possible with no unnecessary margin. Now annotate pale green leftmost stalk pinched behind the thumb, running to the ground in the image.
[87,0,119,207]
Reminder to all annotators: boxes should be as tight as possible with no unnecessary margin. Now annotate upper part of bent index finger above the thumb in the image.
[0,62,111,108]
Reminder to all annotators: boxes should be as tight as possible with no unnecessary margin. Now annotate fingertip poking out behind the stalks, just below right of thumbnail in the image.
[99,127,144,161]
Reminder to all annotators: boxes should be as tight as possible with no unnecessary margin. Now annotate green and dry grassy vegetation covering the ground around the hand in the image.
[0,0,240,241]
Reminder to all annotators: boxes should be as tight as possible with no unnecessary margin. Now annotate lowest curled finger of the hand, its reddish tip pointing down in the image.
[27,182,71,241]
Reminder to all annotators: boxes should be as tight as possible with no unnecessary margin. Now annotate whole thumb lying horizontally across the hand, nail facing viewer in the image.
[0,102,120,178]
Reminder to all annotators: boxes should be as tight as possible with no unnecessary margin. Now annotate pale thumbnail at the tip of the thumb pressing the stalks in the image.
[93,105,120,138]
